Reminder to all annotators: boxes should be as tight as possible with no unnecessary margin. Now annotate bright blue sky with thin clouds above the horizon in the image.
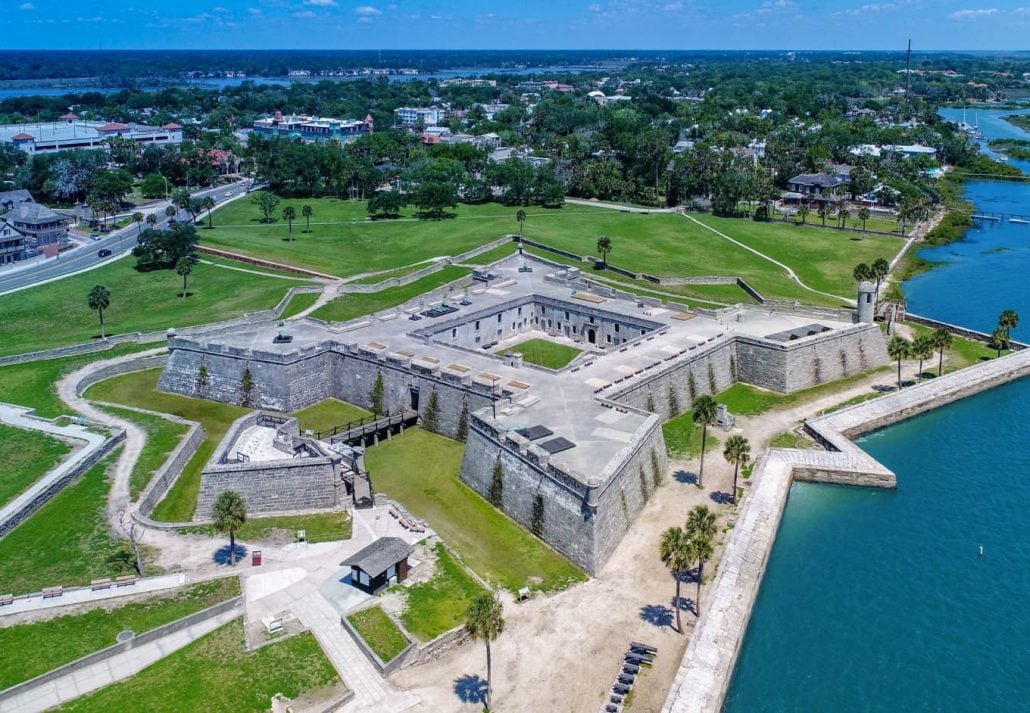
[10,0,1030,50]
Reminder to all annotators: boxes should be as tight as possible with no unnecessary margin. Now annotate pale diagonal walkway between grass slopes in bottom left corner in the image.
[2,605,243,713]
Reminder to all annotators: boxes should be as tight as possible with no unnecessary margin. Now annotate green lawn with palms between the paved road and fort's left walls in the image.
[0,259,309,355]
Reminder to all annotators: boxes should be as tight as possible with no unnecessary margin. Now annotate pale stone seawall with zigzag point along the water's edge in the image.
[662,342,1030,713]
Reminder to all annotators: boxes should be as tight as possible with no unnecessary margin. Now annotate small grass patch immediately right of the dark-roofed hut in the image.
[400,543,485,642]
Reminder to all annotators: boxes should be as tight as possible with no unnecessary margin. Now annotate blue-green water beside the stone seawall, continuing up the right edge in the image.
[725,109,1030,713]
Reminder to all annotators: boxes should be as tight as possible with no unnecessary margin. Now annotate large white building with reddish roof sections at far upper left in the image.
[0,113,182,155]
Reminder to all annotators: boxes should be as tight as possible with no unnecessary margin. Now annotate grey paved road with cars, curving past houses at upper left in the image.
[0,180,249,295]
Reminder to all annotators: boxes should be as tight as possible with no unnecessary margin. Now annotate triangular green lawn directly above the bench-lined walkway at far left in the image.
[0,451,150,593]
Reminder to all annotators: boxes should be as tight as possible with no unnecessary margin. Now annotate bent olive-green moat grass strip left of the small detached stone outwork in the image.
[85,369,247,522]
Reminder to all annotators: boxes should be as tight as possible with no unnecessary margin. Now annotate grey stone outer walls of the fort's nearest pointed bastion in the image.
[460,406,667,575]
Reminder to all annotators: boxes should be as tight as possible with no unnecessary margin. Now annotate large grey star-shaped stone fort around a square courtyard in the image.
[159,257,888,574]
